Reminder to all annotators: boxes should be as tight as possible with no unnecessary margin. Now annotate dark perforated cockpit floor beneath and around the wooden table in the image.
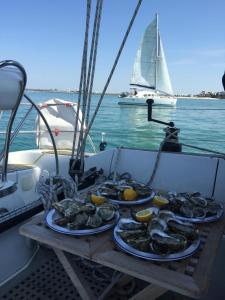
[0,239,225,300]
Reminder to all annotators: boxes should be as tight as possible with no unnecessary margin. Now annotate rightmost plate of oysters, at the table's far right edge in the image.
[157,192,224,223]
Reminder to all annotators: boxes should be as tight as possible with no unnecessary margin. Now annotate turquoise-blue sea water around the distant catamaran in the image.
[0,91,225,156]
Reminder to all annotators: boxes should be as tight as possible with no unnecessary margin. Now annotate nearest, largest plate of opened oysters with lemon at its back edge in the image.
[113,208,200,261]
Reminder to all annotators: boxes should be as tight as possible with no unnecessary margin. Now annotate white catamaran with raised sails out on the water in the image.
[118,14,177,106]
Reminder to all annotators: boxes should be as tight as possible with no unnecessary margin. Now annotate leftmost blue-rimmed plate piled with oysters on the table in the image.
[46,199,120,235]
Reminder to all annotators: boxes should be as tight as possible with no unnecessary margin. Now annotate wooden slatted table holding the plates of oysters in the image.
[20,209,225,300]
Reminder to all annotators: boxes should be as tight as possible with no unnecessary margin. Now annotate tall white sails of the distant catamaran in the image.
[130,15,173,94]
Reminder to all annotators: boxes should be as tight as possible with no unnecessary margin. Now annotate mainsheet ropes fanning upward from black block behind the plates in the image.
[69,0,142,185]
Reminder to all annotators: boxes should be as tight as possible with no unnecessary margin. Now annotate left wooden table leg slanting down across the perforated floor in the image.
[53,248,96,300]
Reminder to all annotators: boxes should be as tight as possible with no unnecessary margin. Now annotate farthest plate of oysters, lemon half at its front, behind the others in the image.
[94,178,155,205]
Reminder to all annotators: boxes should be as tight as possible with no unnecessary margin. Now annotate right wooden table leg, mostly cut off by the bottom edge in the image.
[129,284,168,300]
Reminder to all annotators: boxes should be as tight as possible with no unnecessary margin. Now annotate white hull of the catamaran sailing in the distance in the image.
[118,97,177,106]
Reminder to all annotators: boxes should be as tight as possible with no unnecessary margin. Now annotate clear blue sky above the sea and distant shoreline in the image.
[0,0,225,94]
